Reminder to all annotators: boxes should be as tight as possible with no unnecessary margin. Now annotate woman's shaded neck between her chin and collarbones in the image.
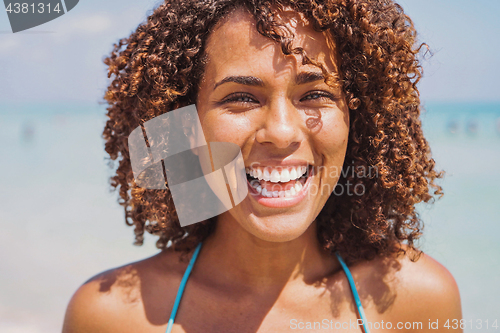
[195,214,338,291]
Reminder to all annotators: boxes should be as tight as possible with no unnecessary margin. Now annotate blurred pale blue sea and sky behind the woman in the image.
[0,0,500,333]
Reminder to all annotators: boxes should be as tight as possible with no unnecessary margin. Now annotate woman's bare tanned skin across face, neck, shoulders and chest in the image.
[63,10,461,333]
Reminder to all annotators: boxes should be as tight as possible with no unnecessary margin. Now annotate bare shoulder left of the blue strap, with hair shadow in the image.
[63,249,187,333]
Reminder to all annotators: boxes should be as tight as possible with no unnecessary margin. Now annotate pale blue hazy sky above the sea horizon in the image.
[0,0,500,104]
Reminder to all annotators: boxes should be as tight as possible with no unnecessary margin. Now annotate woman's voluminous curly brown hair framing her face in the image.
[103,0,443,262]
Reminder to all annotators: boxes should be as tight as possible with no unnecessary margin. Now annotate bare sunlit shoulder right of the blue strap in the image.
[358,246,462,328]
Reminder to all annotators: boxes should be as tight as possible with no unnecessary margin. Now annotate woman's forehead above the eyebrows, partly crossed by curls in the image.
[206,9,337,78]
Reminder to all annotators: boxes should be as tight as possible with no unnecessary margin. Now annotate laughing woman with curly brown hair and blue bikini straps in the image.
[63,0,461,332]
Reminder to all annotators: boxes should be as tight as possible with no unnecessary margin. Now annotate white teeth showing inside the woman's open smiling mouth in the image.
[246,165,313,198]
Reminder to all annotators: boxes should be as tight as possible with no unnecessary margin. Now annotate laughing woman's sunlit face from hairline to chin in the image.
[196,10,349,241]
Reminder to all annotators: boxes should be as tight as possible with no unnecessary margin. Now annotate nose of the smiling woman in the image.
[256,99,303,148]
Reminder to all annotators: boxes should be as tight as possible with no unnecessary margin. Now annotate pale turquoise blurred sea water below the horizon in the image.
[0,103,500,333]
